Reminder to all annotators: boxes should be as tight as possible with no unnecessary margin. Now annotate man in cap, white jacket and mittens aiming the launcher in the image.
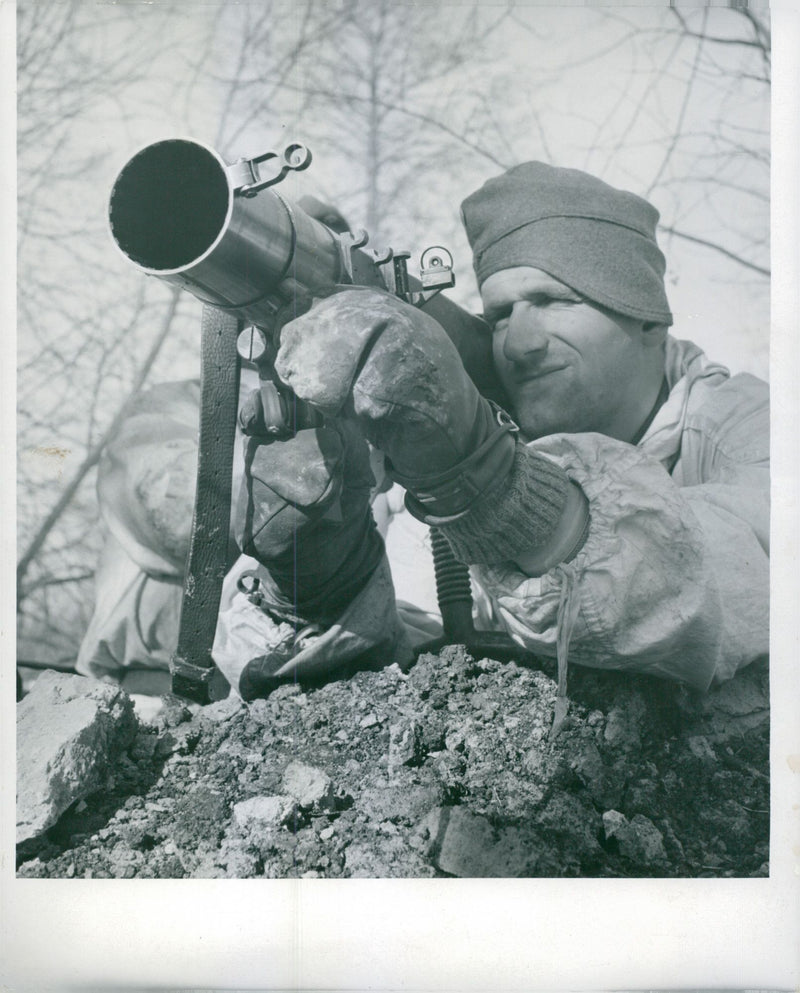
[76,163,769,698]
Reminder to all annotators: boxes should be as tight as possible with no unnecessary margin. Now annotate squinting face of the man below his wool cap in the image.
[481,266,660,440]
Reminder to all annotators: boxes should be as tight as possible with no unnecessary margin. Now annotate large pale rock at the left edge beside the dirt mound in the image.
[17,671,137,844]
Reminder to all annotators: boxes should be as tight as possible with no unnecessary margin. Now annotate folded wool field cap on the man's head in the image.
[461,162,672,325]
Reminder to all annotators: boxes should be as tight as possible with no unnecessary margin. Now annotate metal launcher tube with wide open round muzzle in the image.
[109,138,505,406]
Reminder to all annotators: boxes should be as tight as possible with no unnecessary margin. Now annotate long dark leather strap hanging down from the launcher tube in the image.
[170,306,240,704]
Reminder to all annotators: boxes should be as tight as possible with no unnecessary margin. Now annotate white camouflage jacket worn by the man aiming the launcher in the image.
[76,338,769,689]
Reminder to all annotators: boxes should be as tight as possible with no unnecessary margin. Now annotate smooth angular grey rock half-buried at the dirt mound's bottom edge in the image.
[416,807,538,878]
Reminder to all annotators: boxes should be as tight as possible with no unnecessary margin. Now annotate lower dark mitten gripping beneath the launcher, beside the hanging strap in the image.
[234,402,383,626]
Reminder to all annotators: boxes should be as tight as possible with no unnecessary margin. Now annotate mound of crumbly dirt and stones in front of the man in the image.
[18,647,769,878]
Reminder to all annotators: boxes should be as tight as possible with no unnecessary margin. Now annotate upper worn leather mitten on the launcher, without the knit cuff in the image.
[275,288,516,523]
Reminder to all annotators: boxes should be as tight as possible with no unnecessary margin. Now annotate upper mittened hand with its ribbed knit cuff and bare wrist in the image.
[275,288,588,575]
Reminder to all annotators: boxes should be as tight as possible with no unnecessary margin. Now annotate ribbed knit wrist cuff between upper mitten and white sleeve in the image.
[437,444,569,565]
